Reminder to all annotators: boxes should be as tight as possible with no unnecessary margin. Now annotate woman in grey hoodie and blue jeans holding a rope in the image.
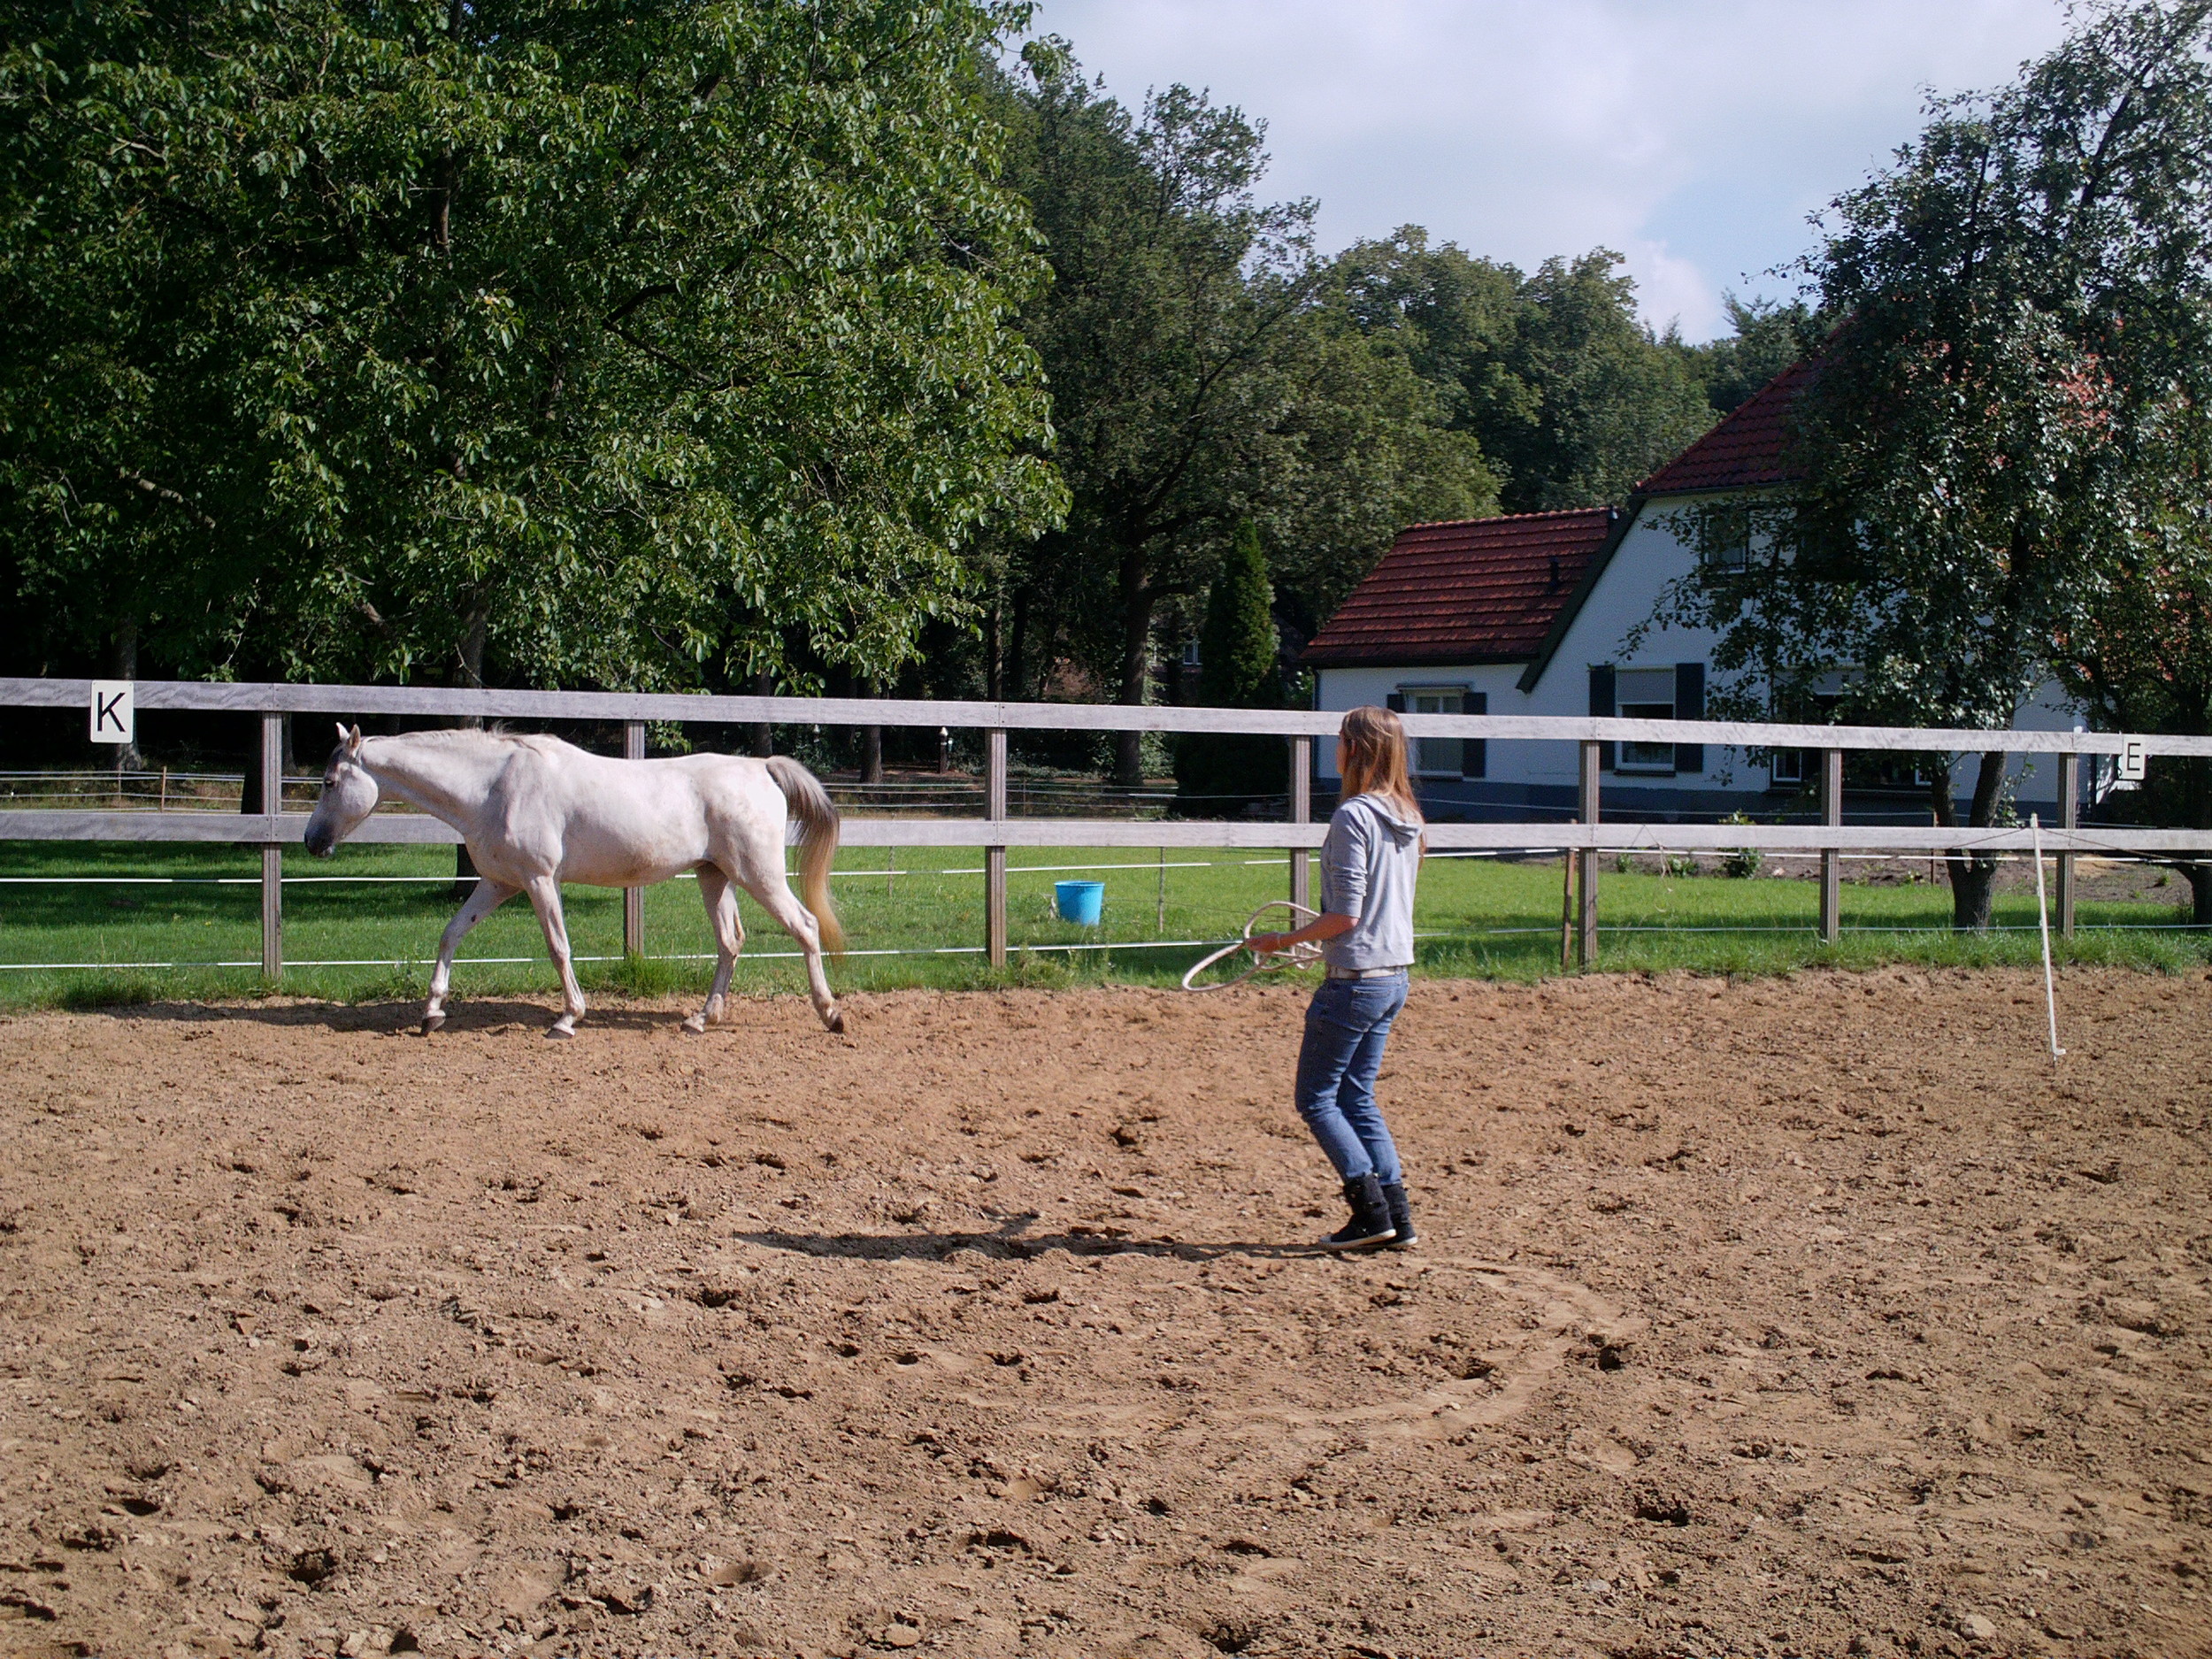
[1252,708,1423,1250]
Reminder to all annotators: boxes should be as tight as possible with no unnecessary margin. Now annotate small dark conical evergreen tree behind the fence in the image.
[1175,520,1287,814]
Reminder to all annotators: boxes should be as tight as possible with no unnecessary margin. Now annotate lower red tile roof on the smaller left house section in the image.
[1301,507,1619,668]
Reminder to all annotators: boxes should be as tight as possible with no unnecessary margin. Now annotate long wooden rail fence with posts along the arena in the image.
[0,680,2212,978]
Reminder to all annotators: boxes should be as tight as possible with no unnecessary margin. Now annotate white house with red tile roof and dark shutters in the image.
[1301,367,2079,823]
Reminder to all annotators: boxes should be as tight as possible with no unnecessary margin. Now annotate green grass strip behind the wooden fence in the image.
[0,843,2212,1007]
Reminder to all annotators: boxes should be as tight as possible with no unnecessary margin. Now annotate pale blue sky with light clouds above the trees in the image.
[1033,0,2066,341]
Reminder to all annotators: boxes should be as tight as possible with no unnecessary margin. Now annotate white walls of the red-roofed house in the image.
[1314,498,2088,817]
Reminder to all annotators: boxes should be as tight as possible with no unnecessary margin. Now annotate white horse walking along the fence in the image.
[308,724,845,1038]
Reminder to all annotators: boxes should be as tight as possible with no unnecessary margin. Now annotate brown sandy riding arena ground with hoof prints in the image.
[0,972,2212,1659]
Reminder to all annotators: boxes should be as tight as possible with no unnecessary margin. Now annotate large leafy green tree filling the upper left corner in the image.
[0,0,1062,686]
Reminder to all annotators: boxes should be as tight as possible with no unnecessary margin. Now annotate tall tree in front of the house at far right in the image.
[1662,0,2212,929]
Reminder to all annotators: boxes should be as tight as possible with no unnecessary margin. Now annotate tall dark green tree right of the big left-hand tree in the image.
[1007,40,1489,783]
